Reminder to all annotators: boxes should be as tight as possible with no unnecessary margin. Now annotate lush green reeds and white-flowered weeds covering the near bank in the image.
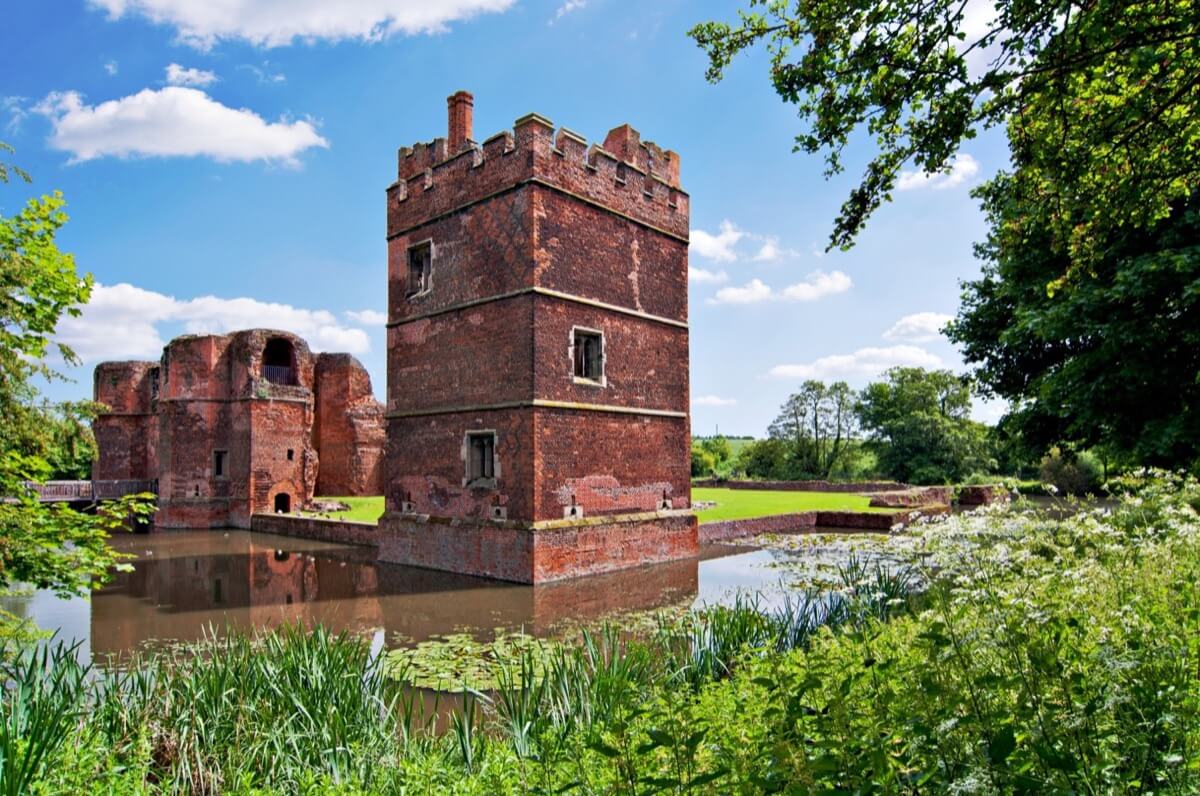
[9,480,1200,794]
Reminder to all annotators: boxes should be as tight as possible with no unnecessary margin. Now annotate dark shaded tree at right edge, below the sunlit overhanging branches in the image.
[947,177,1200,467]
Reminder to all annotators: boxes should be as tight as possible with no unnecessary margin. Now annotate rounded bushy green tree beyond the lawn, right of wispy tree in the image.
[857,367,995,484]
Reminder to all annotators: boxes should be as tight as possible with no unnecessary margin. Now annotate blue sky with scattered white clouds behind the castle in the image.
[0,0,1007,436]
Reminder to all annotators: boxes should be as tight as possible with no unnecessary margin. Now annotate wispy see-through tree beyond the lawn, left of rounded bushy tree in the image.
[767,381,856,478]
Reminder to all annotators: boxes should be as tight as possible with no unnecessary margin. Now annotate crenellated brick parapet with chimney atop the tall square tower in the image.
[388,92,689,241]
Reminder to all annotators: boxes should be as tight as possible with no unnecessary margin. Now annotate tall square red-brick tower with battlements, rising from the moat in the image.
[380,91,697,582]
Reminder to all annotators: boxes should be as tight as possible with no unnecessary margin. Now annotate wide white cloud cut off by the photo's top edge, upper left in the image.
[90,0,515,49]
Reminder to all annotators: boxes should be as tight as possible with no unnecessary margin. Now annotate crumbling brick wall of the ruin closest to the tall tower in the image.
[313,354,386,496]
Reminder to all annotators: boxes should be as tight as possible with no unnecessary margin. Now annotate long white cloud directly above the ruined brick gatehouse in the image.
[58,283,371,363]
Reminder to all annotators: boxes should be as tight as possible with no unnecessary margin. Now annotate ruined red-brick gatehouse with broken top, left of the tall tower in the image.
[92,329,384,528]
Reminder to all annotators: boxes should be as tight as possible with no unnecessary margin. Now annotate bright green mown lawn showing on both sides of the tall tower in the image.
[309,487,893,523]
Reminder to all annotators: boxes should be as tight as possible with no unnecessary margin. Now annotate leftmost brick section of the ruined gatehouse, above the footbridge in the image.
[91,361,158,480]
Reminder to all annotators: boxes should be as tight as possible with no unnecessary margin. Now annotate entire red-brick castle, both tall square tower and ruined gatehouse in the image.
[96,91,698,582]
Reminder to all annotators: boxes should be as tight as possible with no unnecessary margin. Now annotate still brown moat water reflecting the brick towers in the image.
[0,531,820,663]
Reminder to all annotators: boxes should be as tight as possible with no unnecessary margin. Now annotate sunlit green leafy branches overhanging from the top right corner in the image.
[690,0,1200,276]
